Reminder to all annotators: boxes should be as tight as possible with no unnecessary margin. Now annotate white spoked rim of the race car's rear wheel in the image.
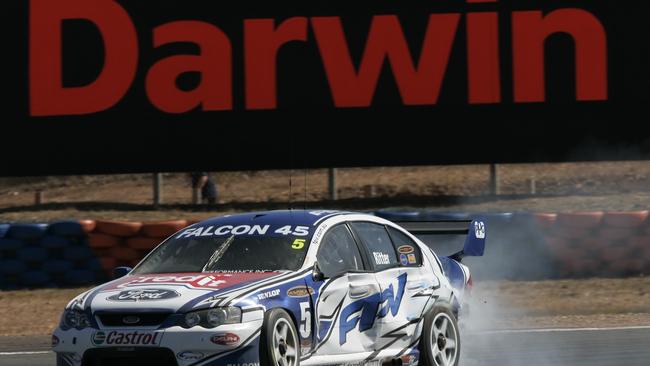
[429,313,458,366]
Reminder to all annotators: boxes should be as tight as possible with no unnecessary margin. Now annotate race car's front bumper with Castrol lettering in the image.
[52,319,262,366]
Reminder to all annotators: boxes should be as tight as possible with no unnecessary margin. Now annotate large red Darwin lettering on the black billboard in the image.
[29,0,608,116]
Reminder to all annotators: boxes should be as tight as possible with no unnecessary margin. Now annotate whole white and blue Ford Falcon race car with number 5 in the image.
[52,210,485,366]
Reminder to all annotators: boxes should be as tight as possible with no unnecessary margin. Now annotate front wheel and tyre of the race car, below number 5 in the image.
[260,309,300,366]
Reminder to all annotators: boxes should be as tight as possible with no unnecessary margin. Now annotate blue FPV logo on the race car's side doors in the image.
[339,273,406,344]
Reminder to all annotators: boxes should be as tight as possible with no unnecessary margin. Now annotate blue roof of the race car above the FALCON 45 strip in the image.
[195,210,359,226]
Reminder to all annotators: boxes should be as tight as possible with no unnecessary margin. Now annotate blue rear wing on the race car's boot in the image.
[395,220,487,261]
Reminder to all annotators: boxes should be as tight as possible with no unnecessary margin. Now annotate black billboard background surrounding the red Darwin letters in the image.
[0,0,650,176]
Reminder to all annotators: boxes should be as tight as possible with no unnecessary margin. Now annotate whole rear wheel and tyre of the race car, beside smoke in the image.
[419,305,460,366]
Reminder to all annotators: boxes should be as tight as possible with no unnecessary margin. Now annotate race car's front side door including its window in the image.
[316,224,380,355]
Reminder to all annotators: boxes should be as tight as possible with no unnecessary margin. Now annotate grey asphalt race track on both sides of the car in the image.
[0,327,650,366]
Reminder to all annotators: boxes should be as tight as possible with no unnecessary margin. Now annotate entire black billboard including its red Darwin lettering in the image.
[0,0,650,175]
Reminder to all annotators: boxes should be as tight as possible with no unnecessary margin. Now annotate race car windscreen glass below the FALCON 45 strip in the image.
[131,230,309,274]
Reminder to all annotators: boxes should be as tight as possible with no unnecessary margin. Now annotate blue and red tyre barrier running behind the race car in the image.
[0,209,650,290]
